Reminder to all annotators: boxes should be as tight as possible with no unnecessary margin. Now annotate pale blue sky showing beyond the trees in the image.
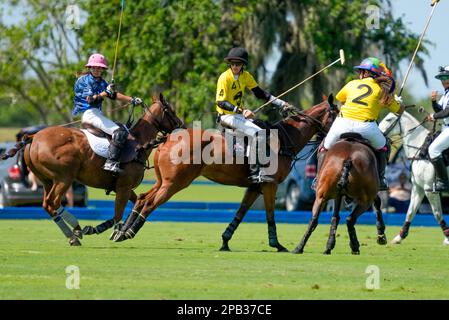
[0,0,449,98]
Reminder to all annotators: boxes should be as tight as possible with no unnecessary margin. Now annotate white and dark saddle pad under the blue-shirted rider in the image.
[81,123,141,163]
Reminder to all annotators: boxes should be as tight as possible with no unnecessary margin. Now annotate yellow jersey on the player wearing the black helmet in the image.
[216,68,258,114]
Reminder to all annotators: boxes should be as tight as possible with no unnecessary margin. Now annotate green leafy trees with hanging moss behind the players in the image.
[0,0,434,125]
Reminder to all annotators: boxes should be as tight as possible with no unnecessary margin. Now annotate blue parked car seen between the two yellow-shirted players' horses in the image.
[252,140,320,211]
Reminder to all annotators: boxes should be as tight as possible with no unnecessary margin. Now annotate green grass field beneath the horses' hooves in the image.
[0,220,449,300]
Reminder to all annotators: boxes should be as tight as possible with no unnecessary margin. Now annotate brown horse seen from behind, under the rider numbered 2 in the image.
[294,134,387,254]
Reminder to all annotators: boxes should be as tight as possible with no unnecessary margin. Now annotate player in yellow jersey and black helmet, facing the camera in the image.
[216,47,289,183]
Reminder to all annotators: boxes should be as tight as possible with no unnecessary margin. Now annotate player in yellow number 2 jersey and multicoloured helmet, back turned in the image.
[318,57,405,190]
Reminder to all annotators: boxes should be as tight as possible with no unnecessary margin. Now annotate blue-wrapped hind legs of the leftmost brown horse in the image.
[41,179,82,246]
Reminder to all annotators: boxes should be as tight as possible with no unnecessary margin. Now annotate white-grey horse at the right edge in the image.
[379,112,449,245]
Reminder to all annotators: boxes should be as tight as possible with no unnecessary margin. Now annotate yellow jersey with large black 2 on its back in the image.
[336,77,400,122]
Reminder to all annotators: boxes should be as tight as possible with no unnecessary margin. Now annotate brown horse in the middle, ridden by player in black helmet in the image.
[114,96,338,251]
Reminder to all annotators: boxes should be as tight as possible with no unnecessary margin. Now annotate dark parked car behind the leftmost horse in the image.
[0,127,88,207]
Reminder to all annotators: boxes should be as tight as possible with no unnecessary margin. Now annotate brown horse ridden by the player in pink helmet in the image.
[1,94,185,246]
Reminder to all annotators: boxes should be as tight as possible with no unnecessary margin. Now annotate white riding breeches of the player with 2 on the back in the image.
[324,117,387,150]
